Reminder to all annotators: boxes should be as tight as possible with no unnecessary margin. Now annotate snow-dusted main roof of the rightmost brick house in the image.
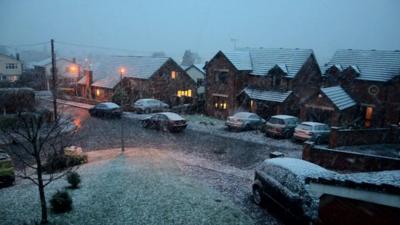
[324,49,400,82]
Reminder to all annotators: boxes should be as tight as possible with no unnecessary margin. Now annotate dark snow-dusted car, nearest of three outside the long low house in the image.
[142,112,187,132]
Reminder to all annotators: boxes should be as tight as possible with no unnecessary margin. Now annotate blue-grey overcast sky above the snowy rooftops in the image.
[0,0,400,61]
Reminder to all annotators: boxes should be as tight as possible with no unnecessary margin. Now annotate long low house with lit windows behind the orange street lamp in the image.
[78,56,196,105]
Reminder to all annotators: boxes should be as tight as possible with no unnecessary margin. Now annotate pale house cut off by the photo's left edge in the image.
[0,54,22,82]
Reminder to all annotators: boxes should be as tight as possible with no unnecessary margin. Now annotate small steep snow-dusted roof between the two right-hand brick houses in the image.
[321,86,356,110]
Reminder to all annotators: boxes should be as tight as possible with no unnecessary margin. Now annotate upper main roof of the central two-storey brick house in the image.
[223,48,313,78]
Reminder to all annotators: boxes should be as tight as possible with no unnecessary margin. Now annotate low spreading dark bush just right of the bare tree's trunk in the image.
[43,154,88,173]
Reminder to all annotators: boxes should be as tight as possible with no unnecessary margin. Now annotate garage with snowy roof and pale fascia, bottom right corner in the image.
[306,170,400,225]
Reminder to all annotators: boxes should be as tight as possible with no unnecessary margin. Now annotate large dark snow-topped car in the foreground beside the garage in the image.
[252,158,334,223]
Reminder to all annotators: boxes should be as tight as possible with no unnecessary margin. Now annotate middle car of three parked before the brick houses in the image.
[265,115,299,138]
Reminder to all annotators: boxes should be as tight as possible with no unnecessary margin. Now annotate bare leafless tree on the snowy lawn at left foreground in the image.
[0,110,76,224]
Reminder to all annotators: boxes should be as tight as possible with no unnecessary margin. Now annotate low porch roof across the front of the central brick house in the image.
[241,88,292,102]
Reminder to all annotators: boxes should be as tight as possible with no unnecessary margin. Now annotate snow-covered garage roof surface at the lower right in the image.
[306,170,400,194]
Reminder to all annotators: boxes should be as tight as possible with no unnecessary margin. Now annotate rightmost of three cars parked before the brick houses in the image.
[293,122,331,143]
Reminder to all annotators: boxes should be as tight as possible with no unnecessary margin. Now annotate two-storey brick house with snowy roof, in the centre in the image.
[205,48,321,118]
